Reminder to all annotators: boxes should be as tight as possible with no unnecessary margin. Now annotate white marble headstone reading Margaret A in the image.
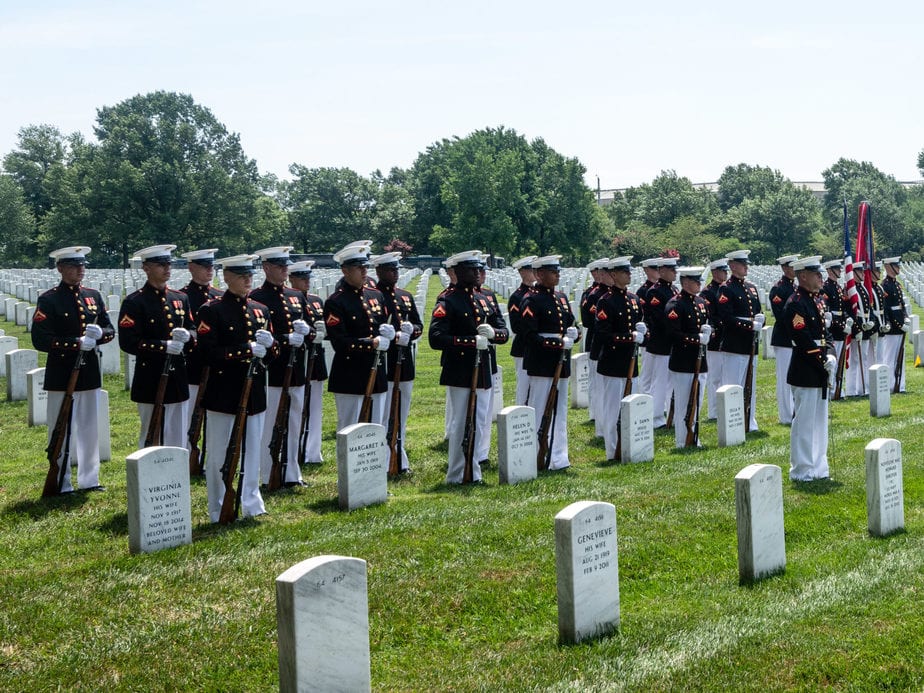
[337,423,388,510]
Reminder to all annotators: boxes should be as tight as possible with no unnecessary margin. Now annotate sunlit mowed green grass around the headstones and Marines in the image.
[0,279,924,691]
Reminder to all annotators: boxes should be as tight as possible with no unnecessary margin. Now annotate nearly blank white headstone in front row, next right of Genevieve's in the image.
[735,464,786,584]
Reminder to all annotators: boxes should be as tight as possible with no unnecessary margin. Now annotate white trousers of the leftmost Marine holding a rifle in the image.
[46,388,100,493]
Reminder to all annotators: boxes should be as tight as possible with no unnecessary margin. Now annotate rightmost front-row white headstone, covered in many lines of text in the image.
[866,438,905,537]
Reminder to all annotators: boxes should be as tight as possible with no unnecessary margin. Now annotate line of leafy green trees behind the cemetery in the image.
[0,91,924,267]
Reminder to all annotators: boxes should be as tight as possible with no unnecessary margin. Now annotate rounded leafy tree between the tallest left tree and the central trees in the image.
[283,164,375,253]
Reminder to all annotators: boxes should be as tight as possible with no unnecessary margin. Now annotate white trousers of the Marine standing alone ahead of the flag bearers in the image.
[789,386,828,481]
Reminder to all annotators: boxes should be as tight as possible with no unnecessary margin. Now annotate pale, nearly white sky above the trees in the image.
[0,0,924,188]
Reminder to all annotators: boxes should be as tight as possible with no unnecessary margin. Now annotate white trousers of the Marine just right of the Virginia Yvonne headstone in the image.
[205,411,266,522]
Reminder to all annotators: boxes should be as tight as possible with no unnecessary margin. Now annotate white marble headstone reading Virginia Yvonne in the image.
[125,446,192,553]
